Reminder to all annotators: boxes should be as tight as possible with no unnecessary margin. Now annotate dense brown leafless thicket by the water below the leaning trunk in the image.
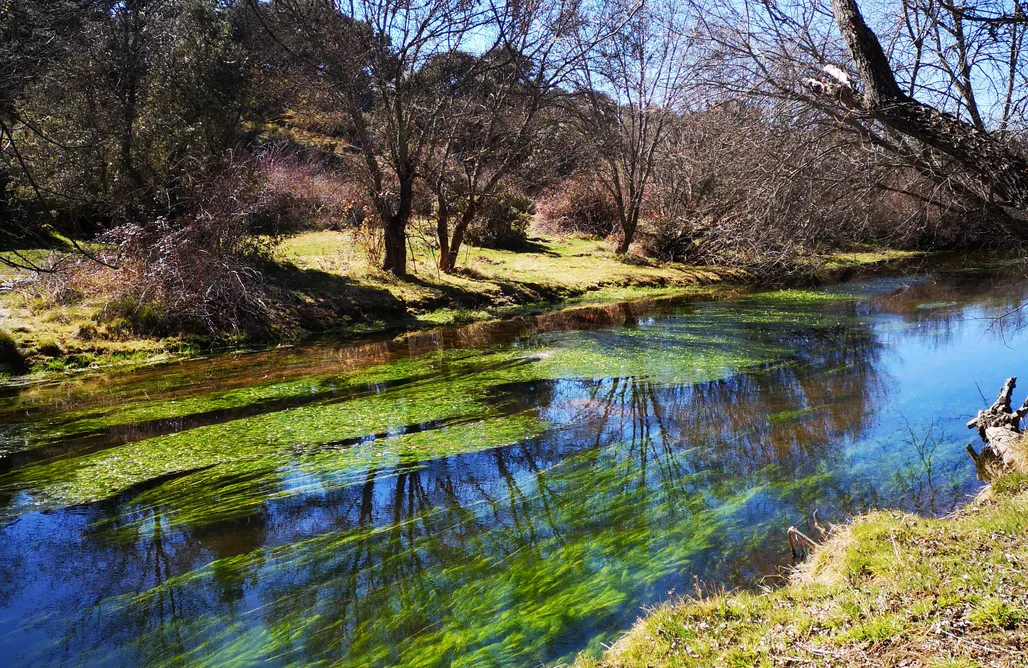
[640,103,994,271]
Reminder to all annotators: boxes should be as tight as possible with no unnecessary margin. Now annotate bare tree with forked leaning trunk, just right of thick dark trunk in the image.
[424,0,600,271]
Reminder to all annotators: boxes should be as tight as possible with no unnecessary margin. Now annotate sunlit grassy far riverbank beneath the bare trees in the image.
[0,231,918,377]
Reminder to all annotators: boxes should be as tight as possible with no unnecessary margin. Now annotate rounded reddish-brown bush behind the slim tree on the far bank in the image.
[539,178,619,238]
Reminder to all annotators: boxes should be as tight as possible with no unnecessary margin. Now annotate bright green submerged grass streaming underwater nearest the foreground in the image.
[82,433,826,666]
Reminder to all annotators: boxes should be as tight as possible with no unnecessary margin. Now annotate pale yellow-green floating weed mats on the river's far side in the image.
[0,295,818,514]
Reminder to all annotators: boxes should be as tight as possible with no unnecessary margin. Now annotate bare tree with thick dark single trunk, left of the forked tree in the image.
[251,0,489,276]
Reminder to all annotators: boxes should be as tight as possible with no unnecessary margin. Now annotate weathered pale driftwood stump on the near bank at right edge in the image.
[967,377,1028,481]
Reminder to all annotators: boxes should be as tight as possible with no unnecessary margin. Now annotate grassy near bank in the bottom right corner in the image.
[576,458,1028,668]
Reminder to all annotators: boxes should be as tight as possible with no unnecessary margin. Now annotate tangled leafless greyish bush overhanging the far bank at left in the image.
[39,158,270,336]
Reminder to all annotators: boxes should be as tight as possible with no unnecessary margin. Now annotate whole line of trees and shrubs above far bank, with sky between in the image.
[0,0,1028,320]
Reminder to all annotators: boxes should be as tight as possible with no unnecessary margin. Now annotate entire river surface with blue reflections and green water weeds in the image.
[0,267,1028,666]
